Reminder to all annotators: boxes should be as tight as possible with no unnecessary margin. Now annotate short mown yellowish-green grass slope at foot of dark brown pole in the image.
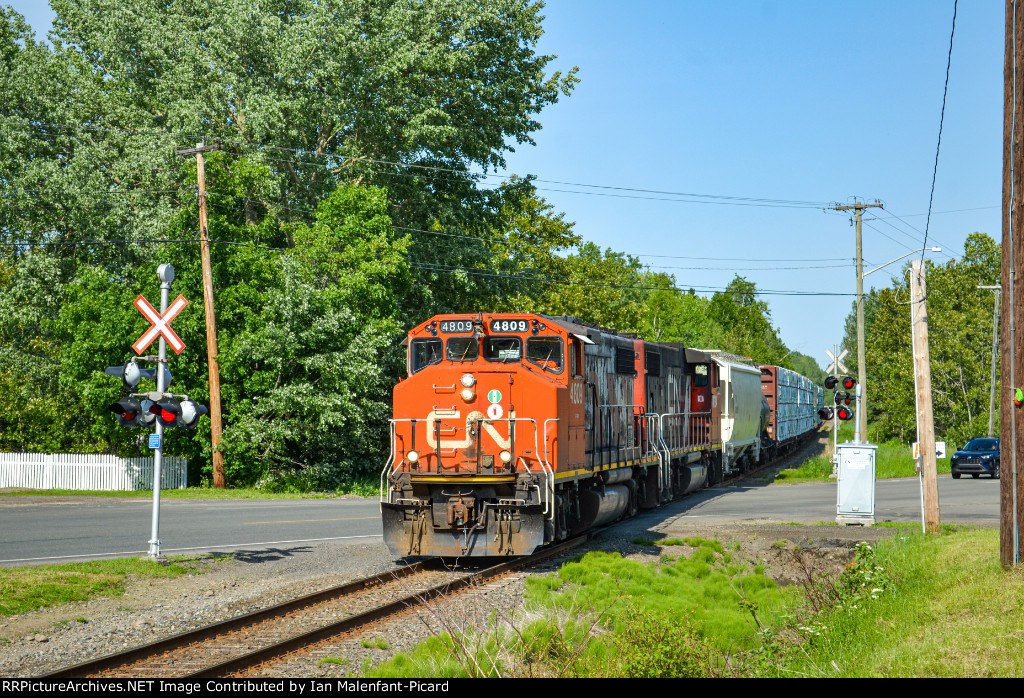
[778,529,1024,678]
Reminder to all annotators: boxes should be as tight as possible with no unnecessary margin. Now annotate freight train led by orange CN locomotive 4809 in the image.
[380,313,823,558]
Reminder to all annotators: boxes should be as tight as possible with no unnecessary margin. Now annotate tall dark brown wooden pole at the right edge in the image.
[999,0,1024,567]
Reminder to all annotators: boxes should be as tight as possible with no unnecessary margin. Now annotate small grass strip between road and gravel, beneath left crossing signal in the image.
[0,558,190,622]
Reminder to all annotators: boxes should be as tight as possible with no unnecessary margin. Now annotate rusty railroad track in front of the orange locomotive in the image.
[45,536,589,679]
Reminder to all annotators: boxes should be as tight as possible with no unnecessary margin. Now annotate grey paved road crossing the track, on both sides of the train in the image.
[0,475,999,566]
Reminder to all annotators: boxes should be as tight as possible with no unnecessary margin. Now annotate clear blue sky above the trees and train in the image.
[10,0,1004,366]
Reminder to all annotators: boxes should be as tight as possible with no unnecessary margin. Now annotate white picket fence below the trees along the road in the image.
[0,453,188,490]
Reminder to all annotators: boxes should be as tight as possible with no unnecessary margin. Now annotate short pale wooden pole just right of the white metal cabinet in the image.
[910,259,939,533]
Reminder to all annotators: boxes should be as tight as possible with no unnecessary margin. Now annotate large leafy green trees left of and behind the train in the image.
[0,0,815,489]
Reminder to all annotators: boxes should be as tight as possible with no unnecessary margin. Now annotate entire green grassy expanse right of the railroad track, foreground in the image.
[362,524,1024,678]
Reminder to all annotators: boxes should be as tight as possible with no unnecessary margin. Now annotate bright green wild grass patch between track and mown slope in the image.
[366,539,799,678]
